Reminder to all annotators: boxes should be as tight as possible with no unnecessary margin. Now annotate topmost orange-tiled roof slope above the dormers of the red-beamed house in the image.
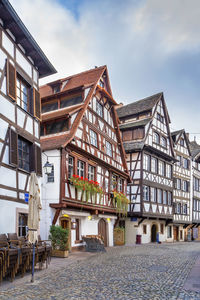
[40,66,106,98]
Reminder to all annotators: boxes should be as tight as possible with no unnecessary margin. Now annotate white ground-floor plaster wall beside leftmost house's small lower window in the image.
[0,200,28,233]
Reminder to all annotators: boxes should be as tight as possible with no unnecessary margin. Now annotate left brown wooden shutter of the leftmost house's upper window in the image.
[7,61,16,101]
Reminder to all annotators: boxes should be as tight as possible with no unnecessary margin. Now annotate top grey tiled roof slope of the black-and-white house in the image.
[117,93,163,118]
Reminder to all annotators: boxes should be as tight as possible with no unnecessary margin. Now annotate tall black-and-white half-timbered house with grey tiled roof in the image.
[117,93,175,243]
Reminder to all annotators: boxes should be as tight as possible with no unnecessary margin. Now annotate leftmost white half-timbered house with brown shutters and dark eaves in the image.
[0,0,55,236]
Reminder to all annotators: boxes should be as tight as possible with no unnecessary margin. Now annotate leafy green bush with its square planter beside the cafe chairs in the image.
[49,225,69,257]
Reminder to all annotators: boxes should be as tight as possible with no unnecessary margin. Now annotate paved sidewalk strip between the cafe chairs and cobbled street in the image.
[0,251,98,290]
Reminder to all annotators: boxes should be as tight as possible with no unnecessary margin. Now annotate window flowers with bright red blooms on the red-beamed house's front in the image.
[70,175,103,202]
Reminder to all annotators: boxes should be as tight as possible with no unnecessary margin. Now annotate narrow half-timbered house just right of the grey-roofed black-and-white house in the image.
[171,129,192,241]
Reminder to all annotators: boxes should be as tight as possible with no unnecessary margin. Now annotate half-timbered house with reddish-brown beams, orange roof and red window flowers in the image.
[40,66,129,249]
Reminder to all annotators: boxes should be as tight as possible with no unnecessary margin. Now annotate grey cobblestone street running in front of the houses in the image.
[0,242,200,300]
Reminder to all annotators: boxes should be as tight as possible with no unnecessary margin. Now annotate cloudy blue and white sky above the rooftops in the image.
[10,0,200,142]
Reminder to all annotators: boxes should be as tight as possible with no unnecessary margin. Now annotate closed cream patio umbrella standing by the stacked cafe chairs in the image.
[28,173,42,243]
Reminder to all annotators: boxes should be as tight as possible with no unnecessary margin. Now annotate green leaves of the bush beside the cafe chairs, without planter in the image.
[49,225,69,251]
